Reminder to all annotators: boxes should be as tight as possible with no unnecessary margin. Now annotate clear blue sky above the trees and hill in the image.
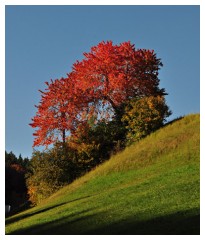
[5,6,200,157]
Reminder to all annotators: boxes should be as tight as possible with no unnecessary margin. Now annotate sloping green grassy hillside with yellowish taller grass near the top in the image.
[6,114,200,235]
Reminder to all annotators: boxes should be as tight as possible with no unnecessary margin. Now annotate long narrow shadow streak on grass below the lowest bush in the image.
[5,196,91,225]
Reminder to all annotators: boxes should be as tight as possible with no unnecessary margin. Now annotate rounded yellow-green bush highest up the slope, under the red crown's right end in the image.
[122,96,171,144]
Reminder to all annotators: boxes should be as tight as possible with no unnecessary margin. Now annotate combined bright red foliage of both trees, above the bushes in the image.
[30,41,165,146]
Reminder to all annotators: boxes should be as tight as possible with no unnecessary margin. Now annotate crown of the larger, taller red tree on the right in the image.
[73,41,164,110]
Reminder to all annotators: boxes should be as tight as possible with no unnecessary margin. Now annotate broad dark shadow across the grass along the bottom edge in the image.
[7,209,200,235]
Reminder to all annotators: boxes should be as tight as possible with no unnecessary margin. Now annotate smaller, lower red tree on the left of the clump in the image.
[30,78,75,146]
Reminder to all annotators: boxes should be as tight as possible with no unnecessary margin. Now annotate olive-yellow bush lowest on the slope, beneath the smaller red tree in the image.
[26,145,75,204]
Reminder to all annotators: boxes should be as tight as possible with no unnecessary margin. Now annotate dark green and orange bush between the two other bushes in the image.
[68,119,126,172]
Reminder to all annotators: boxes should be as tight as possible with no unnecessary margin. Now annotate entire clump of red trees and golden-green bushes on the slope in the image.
[27,41,171,204]
